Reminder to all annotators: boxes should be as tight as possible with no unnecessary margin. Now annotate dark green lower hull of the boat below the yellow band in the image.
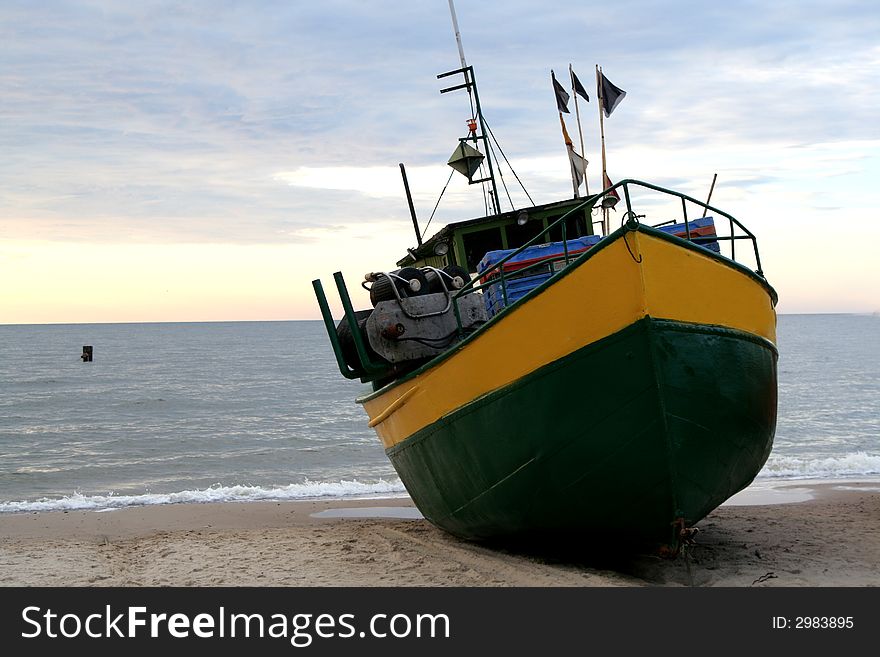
[387,317,777,546]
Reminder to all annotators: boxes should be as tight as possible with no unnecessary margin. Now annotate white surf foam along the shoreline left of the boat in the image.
[0,479,406,513]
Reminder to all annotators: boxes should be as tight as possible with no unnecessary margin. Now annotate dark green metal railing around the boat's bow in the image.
[452,178,764,330]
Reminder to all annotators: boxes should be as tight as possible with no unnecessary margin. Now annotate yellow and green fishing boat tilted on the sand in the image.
[313,26,778,554]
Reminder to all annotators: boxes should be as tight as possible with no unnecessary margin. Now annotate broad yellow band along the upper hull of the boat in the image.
[363,232,776,449]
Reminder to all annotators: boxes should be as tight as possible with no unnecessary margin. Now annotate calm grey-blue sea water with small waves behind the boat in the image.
[0,315,880,513]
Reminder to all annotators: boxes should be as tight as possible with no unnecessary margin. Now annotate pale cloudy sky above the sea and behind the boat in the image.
[0,0,880,324]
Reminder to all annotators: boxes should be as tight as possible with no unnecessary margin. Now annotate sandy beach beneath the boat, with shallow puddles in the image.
[0,482,880,587]
